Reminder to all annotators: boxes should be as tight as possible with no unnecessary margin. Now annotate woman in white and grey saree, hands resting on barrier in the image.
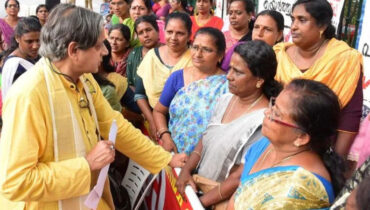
[176,41,281,207]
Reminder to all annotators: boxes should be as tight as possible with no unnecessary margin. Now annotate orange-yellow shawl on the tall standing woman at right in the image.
[274,38,363,108]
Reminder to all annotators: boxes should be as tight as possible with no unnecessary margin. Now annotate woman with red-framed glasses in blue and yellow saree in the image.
[230,79,344,209]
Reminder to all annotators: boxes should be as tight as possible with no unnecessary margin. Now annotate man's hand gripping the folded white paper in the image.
[86,141,115,171]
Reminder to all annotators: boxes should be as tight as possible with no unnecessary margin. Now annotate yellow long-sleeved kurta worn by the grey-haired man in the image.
[0,58,171,210]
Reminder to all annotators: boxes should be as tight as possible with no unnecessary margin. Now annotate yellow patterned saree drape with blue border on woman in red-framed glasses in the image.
[235,166,333,210]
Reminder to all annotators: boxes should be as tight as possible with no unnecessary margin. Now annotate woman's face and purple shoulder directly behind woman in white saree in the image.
[221,10,284,71]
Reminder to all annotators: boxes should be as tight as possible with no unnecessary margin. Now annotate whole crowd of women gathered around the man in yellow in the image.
[0,0,370,209]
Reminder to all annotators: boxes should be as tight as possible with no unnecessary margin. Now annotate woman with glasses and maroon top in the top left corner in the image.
[0,0,20,51]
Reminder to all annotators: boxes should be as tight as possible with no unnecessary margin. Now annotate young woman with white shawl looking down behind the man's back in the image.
[1,17,41,99]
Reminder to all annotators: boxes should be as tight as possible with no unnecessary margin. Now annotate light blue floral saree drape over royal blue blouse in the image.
[168,75,228,155]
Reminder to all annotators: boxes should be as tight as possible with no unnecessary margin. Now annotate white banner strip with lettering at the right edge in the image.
[356,0,370,117]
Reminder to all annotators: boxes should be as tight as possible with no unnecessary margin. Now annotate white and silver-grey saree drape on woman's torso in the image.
[197,93,265,182]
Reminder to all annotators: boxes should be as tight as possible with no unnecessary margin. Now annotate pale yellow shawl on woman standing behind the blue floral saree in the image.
[137,49,192,108]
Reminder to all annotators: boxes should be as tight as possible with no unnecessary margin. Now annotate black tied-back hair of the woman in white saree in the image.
[234,40,283,98]
